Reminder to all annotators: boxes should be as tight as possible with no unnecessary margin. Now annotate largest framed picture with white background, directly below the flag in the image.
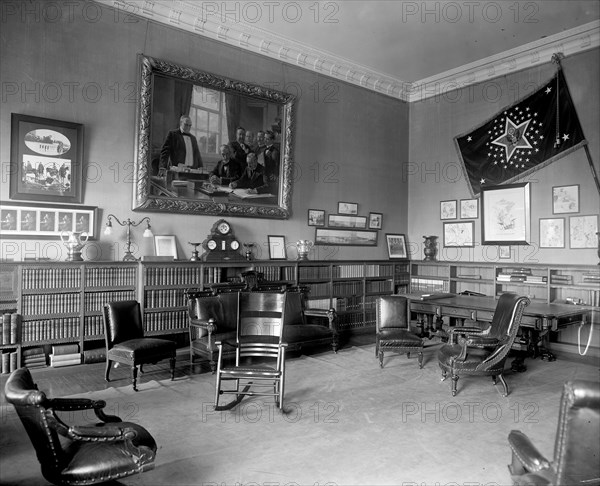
[481,182,531,245]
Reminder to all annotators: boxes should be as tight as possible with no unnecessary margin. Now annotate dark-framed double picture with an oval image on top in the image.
[9,113,83,203]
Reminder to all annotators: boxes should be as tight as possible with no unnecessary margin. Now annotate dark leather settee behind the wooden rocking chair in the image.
[187,287,338,373]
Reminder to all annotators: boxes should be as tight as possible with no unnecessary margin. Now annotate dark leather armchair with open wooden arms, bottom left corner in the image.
[4,368,156,486]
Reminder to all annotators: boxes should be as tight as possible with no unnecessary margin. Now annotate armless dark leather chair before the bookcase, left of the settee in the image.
[104,300,177,391]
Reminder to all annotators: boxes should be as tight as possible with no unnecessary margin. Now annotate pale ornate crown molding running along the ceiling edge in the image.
[95,0,600,102]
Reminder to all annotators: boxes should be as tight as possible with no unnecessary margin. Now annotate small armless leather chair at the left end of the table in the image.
[375,295,423,368]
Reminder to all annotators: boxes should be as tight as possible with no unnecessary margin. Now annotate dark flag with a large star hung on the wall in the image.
[454,69,587,196]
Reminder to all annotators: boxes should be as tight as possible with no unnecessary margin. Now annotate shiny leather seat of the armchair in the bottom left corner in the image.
[61,422,156,484]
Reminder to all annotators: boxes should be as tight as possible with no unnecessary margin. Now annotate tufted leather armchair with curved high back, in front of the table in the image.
[438,292,529,396]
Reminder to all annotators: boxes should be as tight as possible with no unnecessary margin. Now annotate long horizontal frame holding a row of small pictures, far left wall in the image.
[0,201,98,240]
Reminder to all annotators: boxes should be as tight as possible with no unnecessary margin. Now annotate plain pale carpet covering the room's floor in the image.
[0,345,598,486]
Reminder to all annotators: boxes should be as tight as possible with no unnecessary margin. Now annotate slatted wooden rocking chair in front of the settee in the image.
[215,292,289,410]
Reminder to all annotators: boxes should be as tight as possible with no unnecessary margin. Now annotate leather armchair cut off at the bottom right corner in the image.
[508,380,600,486]
